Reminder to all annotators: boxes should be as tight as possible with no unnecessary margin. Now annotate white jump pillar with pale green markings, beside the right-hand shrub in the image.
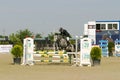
[80,38,92,66]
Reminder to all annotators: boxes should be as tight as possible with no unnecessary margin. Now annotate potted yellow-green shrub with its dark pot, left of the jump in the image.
[11,45,23,64]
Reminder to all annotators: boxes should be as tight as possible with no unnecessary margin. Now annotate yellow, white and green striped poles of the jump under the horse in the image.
[33,52,69,63]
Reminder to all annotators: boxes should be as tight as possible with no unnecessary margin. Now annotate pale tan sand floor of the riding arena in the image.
[0,54,120,80]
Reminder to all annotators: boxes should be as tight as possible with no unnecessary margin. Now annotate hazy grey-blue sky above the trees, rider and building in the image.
[0,0,120,36]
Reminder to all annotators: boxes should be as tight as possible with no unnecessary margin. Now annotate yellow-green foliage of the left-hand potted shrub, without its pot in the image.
[11,45,23,58]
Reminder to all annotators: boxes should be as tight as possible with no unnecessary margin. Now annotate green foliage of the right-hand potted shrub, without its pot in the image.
[90,47,102,60]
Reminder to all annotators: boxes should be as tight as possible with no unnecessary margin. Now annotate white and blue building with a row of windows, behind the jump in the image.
[83,20,120,44]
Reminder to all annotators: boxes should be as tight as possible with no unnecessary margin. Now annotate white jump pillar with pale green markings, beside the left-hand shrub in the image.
[23,38,34,65]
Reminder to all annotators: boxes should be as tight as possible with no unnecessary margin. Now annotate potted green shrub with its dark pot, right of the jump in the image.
[90,46,102,65]
